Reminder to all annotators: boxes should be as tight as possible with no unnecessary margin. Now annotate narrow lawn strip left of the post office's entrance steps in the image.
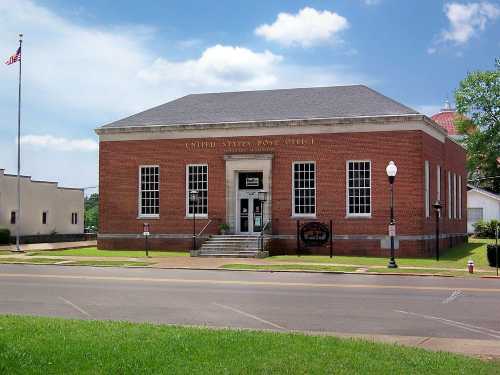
[28,247,189,258]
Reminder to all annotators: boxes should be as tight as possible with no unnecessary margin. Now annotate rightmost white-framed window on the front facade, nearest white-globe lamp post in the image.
[346,160,372,216]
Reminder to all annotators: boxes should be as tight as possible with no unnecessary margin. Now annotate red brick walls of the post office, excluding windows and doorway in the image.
[99,131,466,255]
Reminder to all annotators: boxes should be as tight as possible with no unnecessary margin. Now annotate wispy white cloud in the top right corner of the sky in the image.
[441,2,500,44]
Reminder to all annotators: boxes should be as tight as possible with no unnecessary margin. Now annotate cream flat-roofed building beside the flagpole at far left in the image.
[0,169,84,241]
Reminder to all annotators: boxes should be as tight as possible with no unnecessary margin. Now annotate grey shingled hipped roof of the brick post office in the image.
[102,85,418,128]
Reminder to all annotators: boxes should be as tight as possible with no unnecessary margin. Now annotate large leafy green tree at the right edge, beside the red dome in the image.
[455,58,500,193]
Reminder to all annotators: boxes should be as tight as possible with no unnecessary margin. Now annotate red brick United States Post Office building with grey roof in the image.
[96,86,467,256]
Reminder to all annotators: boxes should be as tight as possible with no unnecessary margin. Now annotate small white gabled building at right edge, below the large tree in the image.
[467,185,500,233]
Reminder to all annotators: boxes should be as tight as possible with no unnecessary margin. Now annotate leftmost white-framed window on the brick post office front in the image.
[139,165,160,217]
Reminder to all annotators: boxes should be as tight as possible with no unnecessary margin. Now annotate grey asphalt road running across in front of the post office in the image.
[0,265,500,343]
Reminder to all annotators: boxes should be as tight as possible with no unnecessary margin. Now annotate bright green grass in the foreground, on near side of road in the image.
[0,316,500,375]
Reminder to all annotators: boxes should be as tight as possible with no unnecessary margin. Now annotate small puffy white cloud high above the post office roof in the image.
[255,7,349,47]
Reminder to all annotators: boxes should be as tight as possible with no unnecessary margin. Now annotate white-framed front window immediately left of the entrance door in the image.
[186,164,208,216]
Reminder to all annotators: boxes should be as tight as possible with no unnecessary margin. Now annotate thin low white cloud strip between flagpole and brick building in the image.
[21,134,99,152]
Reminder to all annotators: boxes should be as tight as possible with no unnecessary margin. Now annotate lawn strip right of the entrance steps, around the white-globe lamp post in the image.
[274,238,495,270]
